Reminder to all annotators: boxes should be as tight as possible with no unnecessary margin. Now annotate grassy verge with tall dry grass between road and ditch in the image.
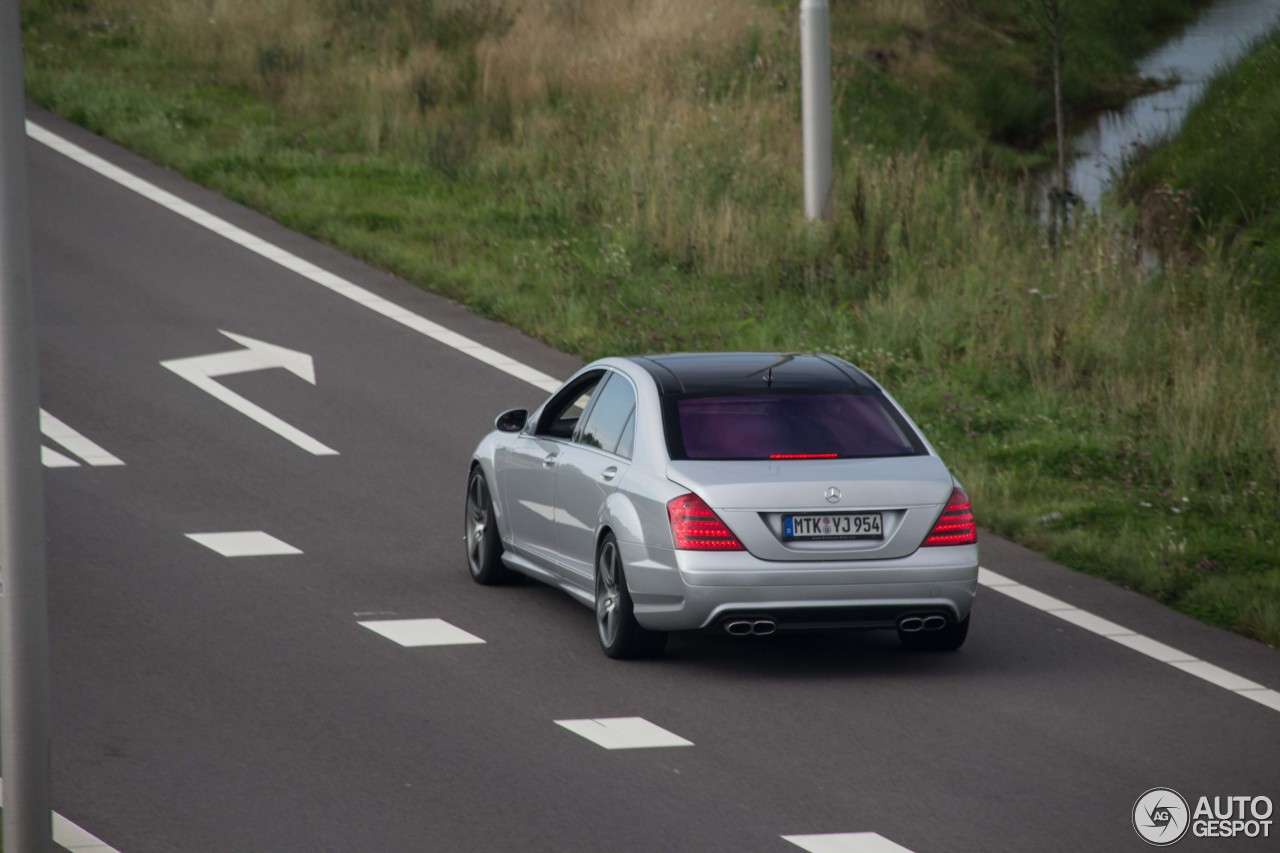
[23,0,1280,643]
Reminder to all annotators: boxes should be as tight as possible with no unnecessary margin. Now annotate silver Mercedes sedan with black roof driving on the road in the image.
[466,352,978,658]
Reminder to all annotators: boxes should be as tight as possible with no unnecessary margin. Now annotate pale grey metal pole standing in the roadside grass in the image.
[800,0,832,220]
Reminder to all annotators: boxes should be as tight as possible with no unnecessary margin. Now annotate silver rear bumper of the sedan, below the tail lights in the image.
[623,546,978,630]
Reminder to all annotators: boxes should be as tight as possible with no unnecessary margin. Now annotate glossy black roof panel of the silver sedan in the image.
[632,352,874,396]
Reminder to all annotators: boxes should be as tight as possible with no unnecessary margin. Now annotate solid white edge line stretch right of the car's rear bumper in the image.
[978,567,1280,711]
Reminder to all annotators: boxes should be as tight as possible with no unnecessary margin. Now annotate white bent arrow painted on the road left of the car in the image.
[160,329,338,456]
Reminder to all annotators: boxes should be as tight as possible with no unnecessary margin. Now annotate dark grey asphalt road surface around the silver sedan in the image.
[28,109,1280,853]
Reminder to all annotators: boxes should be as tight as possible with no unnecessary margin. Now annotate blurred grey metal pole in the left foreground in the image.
[0,0,52,853]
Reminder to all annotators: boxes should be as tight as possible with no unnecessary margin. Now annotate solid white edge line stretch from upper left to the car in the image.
[27,120,561,393]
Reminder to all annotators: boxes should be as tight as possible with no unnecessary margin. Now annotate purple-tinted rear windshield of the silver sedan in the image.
[663,391,927,460]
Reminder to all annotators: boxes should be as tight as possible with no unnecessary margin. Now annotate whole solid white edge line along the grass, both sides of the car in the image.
[27,122,1280,711]
